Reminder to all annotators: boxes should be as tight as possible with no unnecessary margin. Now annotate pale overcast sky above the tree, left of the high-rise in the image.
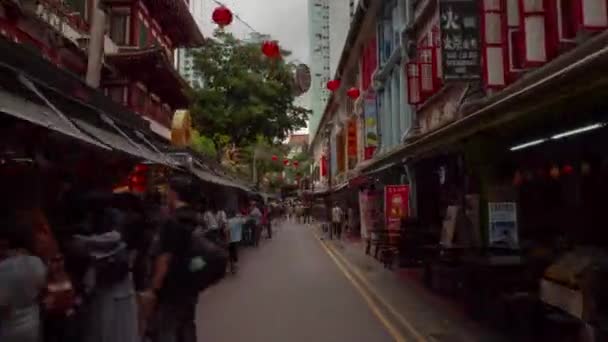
[196,0,309,63]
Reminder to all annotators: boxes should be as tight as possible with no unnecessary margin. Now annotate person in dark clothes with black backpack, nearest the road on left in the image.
[141,175,228,342]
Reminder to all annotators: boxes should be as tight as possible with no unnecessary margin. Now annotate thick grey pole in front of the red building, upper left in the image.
[86,0,106,88]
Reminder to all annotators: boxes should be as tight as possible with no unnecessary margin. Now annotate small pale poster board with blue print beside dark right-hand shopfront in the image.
[488,202,519,248]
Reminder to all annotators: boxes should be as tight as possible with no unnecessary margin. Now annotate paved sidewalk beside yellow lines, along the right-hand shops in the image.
[315,229,507,342]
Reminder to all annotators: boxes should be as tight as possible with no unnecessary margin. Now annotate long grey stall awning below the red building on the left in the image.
[0,39,174,166]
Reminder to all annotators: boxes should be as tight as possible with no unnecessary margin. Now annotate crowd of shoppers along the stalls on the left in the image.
[0,171,272,342]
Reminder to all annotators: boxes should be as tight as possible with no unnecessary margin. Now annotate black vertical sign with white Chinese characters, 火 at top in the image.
[439,0,481,81]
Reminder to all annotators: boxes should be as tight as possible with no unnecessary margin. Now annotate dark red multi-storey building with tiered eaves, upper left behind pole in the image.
[0,0,203,139]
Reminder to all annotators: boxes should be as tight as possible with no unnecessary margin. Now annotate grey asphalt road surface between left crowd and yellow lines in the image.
[197,224,393,342]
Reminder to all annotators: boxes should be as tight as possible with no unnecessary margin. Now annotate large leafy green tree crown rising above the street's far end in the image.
[191,30,309,155]
